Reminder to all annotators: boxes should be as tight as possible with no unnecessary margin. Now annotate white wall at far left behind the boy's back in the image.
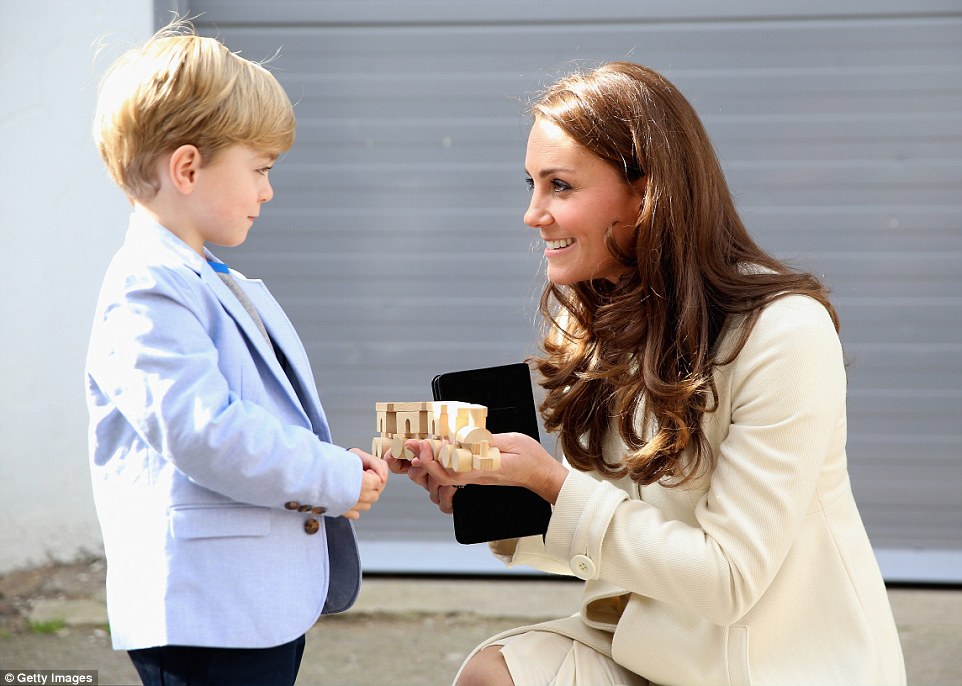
[0,0,153,572]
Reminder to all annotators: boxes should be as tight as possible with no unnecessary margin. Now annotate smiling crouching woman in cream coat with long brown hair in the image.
[389,63,905,686]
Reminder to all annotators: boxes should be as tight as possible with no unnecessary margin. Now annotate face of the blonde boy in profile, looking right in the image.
[181,145,276,253]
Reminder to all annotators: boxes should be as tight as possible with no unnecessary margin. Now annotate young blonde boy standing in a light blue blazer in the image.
[86,23,387,686]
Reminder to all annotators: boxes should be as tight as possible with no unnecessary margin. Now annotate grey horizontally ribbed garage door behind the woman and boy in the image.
[178,0,962,582]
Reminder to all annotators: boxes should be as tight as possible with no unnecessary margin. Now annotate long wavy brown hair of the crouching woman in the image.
[531,62,838,486]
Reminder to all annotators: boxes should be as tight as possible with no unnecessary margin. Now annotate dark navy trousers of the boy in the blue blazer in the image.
[127,636,304,686]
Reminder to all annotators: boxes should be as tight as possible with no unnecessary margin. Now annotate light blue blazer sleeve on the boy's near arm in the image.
[88,267,362,515]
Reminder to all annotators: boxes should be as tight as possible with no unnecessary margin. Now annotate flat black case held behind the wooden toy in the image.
[431,363,551,544]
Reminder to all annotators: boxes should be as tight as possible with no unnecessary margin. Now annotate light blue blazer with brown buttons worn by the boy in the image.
[86,212,362,650]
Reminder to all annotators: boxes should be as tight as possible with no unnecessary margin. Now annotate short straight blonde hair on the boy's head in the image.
[94,21,295,199]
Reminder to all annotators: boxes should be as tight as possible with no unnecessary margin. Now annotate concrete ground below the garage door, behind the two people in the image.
[0,561,962,686]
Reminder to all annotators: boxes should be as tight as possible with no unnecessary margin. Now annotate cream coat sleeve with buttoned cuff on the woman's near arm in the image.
[545,296,845,625]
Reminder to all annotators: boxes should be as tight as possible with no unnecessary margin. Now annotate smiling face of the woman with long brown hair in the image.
[524,117,644,286]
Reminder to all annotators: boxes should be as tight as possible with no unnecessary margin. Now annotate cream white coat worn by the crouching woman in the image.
[491,296,905,686]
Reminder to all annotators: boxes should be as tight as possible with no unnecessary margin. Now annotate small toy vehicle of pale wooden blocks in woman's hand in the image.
[371,401,501,472]
